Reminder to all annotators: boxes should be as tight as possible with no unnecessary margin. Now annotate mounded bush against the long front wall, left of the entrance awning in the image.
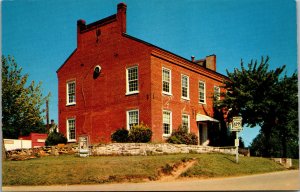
[167,125,198,145]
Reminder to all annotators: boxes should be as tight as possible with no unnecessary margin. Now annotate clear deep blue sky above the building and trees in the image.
[2,0,297,145]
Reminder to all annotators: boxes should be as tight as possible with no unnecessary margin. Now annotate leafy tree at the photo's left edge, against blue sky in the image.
[2,56,50,138]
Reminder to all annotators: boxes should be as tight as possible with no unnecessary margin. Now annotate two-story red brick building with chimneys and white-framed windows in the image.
[57,3,225,144]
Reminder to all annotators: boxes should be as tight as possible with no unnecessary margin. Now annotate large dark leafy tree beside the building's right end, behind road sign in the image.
[216,57,298,156]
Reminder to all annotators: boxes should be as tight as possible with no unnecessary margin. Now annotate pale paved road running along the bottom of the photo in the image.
[2,170,300,191]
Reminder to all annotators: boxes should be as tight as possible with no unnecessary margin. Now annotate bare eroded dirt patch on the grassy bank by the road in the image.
[158,159,197,181]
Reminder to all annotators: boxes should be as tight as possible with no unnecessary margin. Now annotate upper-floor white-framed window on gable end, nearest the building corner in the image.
[126,66,139,95]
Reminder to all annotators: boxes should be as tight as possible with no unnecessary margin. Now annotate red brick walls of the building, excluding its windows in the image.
[57,4,223,143]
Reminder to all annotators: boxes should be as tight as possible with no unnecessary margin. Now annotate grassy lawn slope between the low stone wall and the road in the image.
[2,154,284,186]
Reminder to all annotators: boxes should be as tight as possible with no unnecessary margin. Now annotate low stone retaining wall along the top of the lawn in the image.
[6,143,235,160]
